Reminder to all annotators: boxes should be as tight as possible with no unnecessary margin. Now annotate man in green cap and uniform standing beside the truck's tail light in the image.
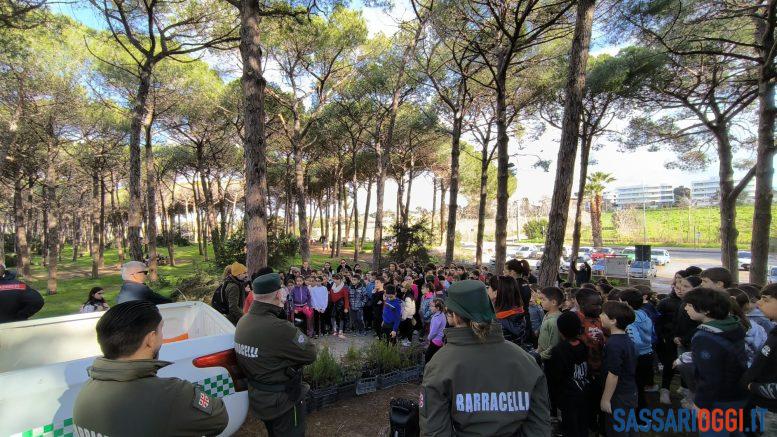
[235,273,316,437]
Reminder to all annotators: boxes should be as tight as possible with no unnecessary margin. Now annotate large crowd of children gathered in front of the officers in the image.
[260,260,777,436]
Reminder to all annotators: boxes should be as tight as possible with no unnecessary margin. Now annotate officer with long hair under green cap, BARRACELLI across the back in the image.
[419,280,551,437]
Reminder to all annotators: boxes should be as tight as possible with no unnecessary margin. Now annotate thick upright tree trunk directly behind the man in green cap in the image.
[240,0,267,275]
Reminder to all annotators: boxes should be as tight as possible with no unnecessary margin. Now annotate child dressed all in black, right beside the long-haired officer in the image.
[547,312,588,437]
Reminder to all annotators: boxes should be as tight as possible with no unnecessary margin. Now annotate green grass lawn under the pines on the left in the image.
[16,245,371,318]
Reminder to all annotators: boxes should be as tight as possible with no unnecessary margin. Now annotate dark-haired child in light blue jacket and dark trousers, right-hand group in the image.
[621,288,655,408]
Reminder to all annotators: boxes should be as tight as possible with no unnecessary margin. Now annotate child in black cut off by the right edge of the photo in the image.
[741,284,777,430]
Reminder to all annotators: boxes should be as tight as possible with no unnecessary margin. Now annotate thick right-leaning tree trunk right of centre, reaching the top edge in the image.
[538,0,596,286]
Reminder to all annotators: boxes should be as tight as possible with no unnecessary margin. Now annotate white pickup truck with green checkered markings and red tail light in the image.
[0,302,248,436]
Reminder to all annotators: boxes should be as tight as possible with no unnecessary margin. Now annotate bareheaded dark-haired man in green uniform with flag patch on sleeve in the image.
[73,300,229,437]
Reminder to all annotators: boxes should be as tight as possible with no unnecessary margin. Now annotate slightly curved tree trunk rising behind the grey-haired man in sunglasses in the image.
[127,62,153,261]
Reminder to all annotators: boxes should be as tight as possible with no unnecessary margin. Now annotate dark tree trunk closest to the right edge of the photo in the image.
[750,12,777,285]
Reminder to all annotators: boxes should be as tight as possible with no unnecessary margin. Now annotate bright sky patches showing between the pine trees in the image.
[53,0,777,210]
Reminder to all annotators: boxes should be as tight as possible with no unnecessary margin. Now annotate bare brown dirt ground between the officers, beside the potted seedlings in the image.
[235,384,418,437]
